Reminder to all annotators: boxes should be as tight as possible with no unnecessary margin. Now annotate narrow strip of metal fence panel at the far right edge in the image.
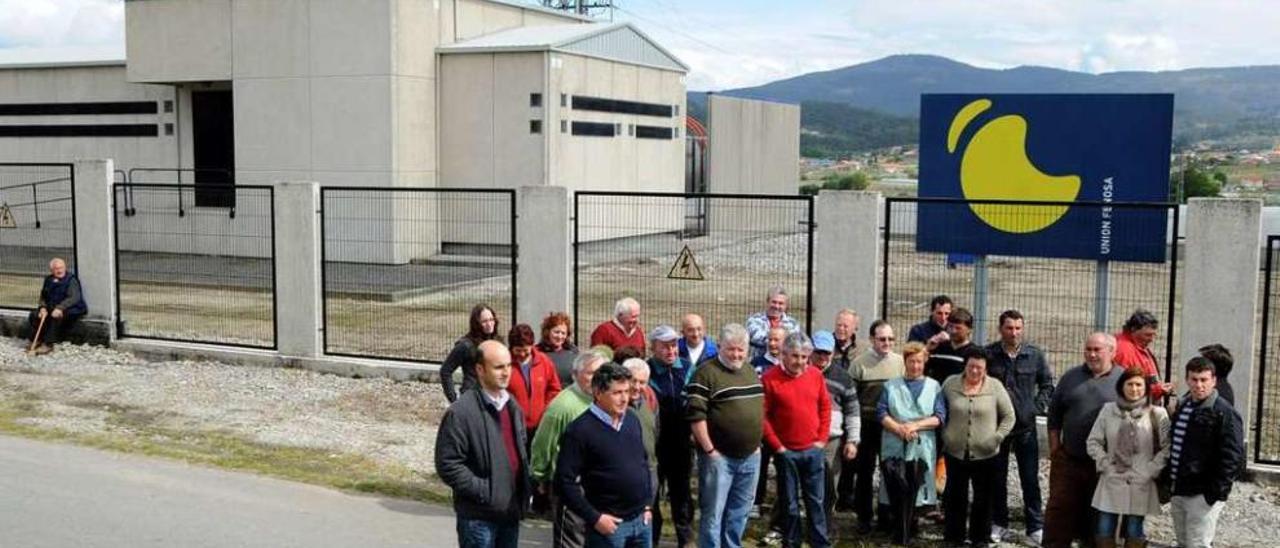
[1253,234,1280,465]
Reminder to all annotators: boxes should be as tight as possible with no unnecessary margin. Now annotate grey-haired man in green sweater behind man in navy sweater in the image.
[530,350,608,547]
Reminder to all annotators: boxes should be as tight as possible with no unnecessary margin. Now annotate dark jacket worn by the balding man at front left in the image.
[435,389,532,521]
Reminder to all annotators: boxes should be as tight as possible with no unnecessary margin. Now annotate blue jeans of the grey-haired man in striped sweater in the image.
[698,451,757,548]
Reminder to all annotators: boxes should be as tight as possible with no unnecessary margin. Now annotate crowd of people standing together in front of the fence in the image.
[424,287,1244,548]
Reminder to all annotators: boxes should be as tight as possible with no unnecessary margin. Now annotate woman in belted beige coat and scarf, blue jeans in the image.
[1087,367,1170,548]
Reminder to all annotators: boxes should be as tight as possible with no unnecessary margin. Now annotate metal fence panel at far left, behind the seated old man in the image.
[0,164,75,310]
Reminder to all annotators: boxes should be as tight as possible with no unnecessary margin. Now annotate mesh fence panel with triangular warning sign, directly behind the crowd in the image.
[573,192,814,344]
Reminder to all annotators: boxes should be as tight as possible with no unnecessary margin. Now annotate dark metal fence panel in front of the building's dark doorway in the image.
[113,183,276,350]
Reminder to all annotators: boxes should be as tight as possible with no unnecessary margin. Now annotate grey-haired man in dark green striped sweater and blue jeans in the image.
[685,324,764,548]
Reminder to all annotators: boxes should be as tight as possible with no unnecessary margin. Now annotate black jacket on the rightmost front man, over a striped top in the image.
[1166,391,1244,504]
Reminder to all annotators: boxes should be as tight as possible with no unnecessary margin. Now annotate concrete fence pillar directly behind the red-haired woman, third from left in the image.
[513,186,573,330]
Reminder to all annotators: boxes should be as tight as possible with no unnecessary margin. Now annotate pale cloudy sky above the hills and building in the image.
[0,0,1280,90]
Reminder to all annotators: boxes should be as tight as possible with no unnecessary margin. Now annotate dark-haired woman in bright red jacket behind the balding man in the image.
[507,324,561,439]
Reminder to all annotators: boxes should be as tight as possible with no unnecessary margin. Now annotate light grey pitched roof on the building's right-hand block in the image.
[436,23,689,72]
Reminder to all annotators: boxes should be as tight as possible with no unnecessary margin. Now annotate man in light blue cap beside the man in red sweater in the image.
[809,330,861,524]
